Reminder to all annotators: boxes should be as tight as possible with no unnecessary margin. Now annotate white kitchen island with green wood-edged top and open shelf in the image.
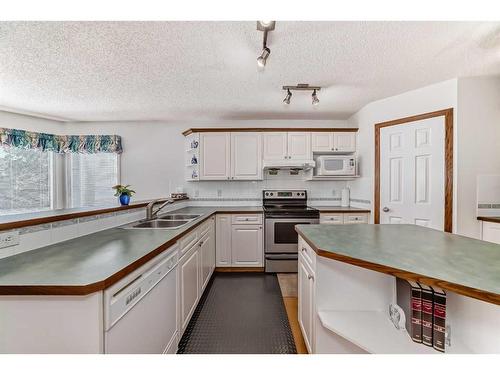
[296,224,500,353]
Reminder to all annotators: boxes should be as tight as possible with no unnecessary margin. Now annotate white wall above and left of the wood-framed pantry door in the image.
[348,79,457,226]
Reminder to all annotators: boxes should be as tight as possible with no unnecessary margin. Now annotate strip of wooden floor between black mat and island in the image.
[277,273,308,354]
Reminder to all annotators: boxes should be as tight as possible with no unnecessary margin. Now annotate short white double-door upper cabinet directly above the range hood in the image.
[263,132,312,161]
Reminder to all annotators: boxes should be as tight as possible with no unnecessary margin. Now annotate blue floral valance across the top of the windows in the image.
[0,128,122,154]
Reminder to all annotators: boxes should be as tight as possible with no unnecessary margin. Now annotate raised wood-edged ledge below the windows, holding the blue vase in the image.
[0,198,187,231]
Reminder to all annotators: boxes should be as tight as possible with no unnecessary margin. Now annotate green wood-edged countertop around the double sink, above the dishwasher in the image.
[0,206,262,295]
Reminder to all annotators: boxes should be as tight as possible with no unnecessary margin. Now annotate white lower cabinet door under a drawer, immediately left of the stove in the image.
[231,225,263,267]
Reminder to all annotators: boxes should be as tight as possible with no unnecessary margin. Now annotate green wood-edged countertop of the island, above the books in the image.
[296,224,500,305]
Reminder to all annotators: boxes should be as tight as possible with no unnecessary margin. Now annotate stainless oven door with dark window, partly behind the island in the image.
[264,218,319,253]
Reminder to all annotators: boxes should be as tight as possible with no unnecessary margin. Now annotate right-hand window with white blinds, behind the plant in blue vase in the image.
[67,153,119,207]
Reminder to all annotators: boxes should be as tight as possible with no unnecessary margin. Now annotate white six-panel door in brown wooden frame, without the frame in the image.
[380,117,445,230]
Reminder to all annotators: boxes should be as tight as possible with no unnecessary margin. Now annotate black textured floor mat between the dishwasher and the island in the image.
[178,273,297,354]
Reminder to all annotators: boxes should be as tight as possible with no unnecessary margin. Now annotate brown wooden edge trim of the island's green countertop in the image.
[295,228,500,305]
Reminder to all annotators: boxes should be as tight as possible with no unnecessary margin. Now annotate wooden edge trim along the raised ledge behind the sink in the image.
[0,198,188,231]
